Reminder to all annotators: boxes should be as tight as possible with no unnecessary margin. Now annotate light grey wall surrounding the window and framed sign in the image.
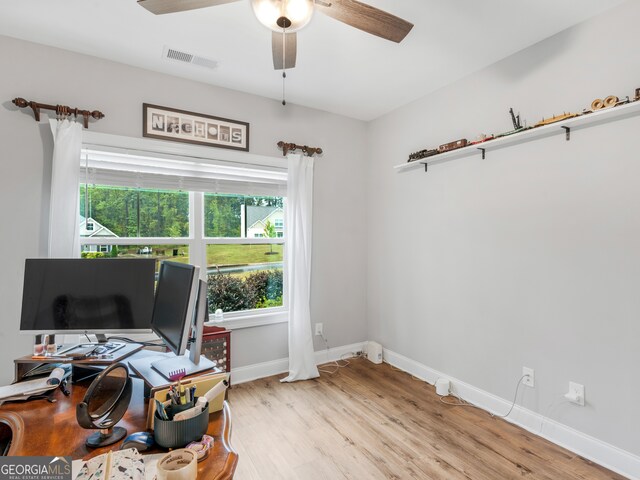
[0,36,366,384]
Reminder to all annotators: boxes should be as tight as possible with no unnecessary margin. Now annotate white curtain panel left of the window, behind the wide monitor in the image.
[49,119,82,258]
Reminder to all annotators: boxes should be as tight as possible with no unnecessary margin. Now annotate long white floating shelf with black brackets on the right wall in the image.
[393,101,640,172]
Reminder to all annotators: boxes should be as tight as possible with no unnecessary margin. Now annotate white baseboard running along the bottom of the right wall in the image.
[383,349,640,480]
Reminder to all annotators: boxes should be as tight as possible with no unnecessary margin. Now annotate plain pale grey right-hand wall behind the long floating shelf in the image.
[367,1,640,455]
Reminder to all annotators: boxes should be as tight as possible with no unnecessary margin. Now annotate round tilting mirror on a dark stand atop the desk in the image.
[76,363,132,447]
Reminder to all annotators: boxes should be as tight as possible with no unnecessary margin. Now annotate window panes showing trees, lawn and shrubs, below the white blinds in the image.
[80,185,284,314]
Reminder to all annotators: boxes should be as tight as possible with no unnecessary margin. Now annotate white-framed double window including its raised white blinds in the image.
[79,146,286,326]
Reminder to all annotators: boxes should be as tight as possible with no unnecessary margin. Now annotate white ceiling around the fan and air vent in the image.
[0,0,625,120]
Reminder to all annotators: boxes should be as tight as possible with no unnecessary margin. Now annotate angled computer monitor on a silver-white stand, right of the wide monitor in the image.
[151,261,216,379]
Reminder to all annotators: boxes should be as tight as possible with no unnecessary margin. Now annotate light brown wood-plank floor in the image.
[229,359,623,480]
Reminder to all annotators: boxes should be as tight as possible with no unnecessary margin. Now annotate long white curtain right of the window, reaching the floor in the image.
[281,155,320,382]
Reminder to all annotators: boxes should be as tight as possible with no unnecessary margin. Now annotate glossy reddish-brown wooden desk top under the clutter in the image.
[0,379,238,480]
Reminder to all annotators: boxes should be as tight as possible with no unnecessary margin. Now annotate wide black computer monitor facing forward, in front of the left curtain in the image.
[20,258,155,334]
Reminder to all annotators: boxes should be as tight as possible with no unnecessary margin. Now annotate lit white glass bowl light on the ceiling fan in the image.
[251,0,313,32]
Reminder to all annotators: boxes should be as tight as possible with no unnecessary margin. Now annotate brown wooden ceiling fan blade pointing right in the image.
[315,0,413,43]
